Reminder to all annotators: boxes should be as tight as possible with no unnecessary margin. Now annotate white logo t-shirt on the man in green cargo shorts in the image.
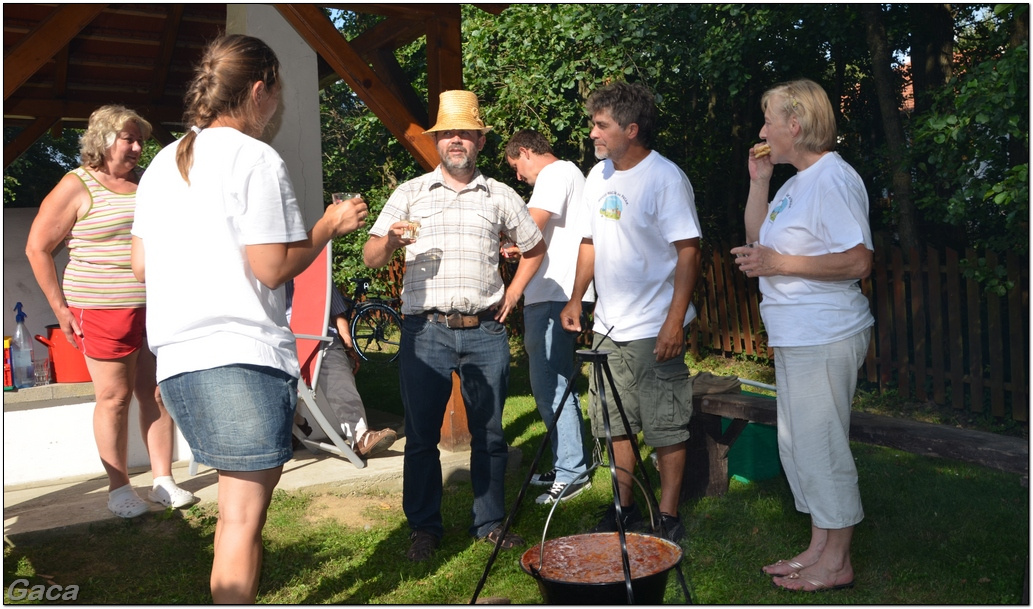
[582,151,700,341]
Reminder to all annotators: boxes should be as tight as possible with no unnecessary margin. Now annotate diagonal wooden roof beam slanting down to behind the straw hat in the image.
[275,4,440,170]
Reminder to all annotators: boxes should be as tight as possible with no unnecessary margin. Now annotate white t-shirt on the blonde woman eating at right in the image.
[760,153,875,347]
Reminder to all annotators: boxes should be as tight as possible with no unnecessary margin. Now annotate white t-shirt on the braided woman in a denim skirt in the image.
[132,127,306,381]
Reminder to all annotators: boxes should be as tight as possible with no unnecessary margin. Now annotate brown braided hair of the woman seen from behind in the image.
[176,34,280,184]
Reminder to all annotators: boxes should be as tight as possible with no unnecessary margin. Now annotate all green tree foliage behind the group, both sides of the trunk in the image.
[327,4,1029,291]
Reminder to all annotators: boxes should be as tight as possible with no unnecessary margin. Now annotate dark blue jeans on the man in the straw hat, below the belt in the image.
[399,315,509,539]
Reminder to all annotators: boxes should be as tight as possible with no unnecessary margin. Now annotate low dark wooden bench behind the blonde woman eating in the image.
[682,393,1029,501]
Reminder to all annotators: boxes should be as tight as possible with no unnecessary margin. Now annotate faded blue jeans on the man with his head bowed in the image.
[524,302,588,484]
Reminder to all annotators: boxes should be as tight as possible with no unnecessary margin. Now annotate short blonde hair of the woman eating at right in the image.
[760,78,836,153]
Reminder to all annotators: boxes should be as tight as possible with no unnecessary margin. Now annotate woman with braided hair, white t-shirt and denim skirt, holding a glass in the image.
[132,35,367,603]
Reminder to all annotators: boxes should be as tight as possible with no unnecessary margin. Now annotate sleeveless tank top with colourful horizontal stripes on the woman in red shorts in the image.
[62,167,146,309]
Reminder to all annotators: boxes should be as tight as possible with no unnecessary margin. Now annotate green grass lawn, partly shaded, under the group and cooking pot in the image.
[4,342,1029,605]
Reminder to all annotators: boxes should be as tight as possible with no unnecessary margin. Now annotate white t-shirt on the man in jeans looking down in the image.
[524,161,595,305]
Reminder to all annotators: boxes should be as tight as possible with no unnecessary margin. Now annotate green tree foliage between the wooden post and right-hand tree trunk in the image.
[464,4,884,247]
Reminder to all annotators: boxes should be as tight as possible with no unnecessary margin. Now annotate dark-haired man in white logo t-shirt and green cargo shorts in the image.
[561,83,701,541]
